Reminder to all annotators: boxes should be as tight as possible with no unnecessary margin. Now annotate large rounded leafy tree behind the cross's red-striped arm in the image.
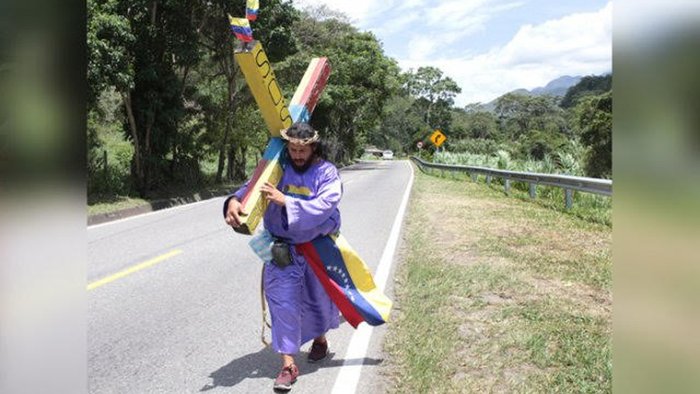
[276,8,399,162]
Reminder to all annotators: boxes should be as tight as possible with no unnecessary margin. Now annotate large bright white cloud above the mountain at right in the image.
[399,3,612,106]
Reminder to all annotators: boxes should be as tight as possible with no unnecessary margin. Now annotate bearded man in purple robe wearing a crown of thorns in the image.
[224,123,342,390]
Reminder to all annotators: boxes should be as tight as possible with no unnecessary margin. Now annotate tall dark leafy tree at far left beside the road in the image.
[88,0,199,195]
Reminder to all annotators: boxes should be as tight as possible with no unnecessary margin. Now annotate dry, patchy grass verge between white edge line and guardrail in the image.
[385,170,612,393]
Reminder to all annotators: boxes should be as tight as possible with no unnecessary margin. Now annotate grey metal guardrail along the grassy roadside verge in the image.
[411,156,612,209]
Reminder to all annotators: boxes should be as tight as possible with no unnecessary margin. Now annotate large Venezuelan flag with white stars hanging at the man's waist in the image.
[296,235,392,328]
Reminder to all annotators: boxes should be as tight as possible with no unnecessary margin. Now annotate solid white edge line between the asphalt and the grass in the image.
[332,163,414,394]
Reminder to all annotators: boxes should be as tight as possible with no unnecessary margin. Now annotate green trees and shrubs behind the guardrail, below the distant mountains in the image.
[426,82,612,182]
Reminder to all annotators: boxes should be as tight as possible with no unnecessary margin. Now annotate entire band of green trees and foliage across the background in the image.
[87,0,612,201]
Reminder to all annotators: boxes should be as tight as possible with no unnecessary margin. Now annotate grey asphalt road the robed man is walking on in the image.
[87,161,412,393]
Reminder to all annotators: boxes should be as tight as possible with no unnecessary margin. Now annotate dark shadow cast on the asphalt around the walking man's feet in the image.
[199,347,384,392]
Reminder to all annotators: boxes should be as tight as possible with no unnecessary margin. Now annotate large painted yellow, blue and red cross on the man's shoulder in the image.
[234,41,331,234]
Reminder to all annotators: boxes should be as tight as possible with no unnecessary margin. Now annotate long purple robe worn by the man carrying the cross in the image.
[224,160,342,354]
